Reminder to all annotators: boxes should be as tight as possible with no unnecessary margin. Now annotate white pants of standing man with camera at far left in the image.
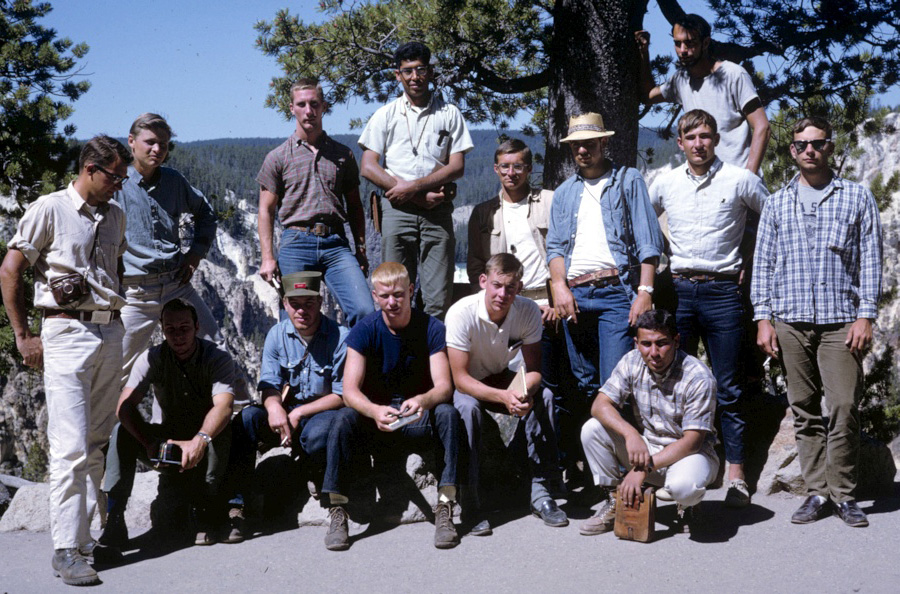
[41,318,125,549]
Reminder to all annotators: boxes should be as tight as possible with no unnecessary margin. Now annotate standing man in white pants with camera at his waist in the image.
[0,136,131,586]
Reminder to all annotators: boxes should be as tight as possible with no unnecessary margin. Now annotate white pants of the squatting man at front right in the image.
[581,418,719,507]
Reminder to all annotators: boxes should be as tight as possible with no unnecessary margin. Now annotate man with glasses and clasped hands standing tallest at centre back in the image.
[359,42,473,318]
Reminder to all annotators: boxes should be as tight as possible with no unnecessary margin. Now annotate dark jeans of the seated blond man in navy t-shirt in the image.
[322,399,460,495]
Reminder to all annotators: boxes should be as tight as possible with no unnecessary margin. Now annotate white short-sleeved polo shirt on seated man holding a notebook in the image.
[446,291,543,380]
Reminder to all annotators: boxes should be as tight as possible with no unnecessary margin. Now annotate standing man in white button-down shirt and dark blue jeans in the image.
[650,109,769,507]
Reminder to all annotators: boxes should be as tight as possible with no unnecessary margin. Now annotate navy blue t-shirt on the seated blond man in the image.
[347,309,447,405]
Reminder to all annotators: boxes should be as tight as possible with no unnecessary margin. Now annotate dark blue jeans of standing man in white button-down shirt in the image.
[675,278,746,464]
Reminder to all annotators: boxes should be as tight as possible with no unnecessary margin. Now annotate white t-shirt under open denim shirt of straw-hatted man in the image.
[568,171,616,278]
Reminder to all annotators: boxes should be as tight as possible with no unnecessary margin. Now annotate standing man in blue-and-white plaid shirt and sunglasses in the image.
[750,117,881,526]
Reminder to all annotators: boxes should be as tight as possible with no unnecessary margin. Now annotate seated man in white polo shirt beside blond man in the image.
[447,253,569,535]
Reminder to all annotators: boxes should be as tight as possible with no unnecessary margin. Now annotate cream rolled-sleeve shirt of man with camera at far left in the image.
[8,184,127,311]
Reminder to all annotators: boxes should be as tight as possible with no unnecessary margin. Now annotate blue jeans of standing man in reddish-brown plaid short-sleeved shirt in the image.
[278,229,375,328]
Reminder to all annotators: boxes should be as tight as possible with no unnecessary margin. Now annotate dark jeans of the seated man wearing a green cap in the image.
[229,404,337,505]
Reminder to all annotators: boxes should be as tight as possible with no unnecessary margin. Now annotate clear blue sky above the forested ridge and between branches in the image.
[43,0,892,141]
